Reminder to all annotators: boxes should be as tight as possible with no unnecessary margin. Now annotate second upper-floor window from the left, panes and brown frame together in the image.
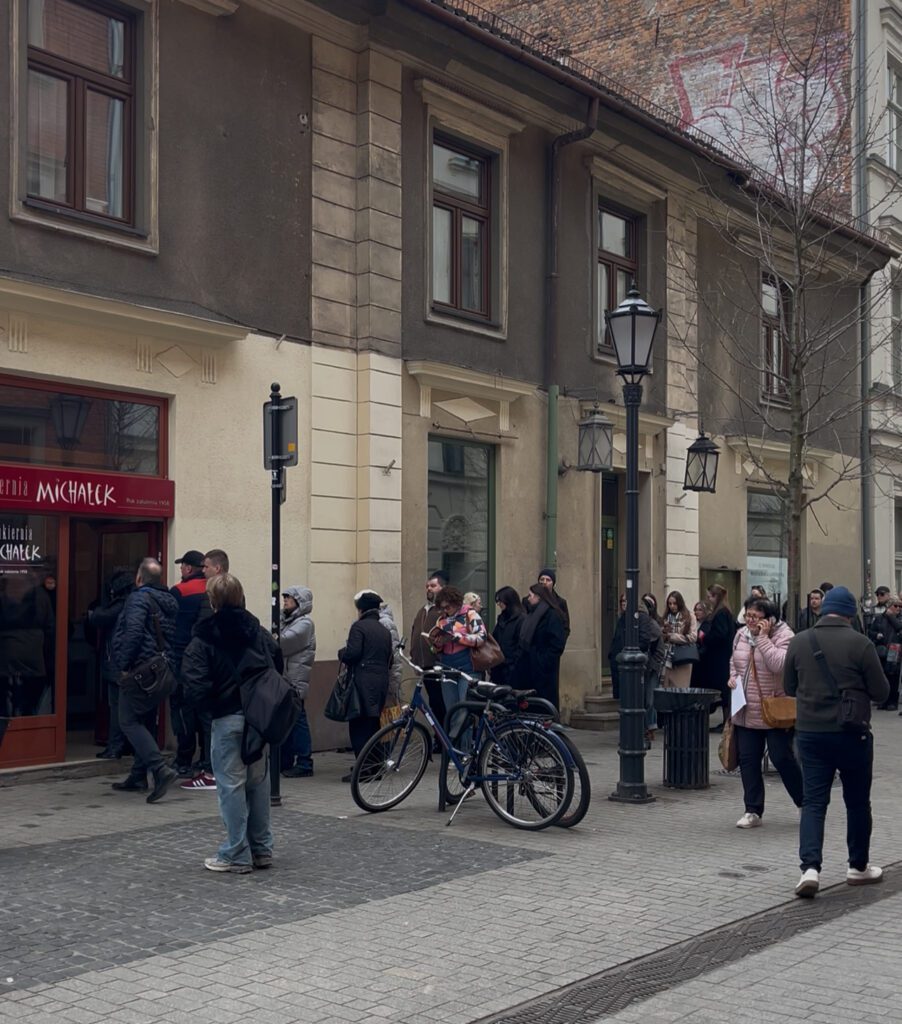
[432,135,492,319]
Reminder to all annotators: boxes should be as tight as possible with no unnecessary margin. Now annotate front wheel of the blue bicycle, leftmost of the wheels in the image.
[351,719,432,814]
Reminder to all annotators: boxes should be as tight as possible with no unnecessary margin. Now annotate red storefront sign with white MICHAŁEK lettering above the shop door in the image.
[0,463,175,519]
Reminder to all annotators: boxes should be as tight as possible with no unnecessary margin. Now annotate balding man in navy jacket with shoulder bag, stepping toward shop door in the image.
[112,558,178,804]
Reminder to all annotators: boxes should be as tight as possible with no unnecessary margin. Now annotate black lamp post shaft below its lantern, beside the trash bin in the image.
[610,383,654,804]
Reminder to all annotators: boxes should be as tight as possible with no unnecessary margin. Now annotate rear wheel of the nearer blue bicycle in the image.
[478,722,573,831]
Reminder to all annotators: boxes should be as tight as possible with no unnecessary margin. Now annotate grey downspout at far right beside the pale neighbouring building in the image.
[854,0,873,596]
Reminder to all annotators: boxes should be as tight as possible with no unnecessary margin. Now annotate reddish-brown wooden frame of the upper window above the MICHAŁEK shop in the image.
[25,0,138,228]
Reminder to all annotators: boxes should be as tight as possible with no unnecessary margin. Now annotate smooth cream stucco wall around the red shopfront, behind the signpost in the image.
[0,310,310,623]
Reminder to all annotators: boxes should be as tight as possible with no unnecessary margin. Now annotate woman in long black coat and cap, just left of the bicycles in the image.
[338,590,394,782]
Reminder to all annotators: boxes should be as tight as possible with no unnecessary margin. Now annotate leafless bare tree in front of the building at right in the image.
[670,0,891,613]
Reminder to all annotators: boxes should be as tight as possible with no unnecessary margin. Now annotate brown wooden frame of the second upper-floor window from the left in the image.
[429,130,496,324]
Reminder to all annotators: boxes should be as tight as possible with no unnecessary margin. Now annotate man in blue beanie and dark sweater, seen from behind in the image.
[783,587,890,898]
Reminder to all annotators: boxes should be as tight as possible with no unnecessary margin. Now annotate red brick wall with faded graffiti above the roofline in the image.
[479,0,851,193]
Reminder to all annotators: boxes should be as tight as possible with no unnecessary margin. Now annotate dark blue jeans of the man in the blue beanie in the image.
[796,731,873,871]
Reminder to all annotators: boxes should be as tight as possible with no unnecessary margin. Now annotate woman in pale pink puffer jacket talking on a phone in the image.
[730,598,802,828]
